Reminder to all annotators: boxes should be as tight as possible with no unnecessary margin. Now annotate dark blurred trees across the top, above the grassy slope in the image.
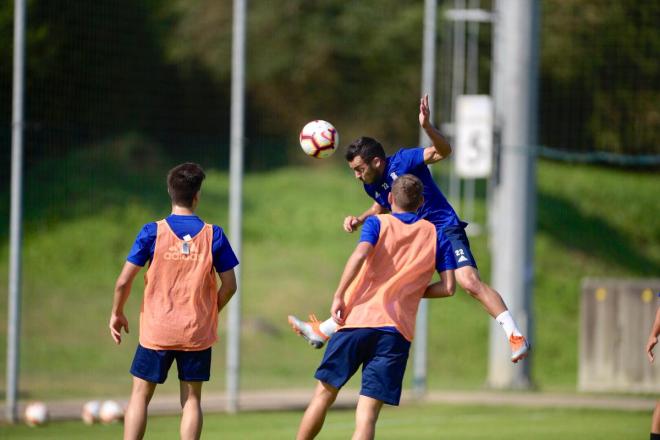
[0,0,660,172]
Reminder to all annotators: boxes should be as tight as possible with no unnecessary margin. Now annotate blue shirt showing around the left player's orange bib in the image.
[126,214,238,273]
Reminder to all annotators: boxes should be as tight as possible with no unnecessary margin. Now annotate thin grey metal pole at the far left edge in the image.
[5,0,26,423]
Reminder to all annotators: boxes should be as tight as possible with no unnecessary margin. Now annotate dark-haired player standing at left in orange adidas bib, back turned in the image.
[109,163,238,439]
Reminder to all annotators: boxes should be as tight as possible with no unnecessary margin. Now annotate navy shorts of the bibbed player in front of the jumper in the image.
[314,328,410,405]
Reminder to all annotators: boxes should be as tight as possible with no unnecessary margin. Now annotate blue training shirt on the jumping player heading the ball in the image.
[364,147,461,230]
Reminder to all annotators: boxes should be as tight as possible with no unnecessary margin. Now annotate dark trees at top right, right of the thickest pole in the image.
[541,0,660,154]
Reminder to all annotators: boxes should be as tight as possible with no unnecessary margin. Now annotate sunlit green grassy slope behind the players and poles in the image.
[0,150,660,398]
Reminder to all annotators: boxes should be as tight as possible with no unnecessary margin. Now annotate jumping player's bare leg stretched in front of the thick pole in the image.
[456,266,530,363]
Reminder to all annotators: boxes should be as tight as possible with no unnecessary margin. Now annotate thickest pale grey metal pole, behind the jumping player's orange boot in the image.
[488,0,539,388]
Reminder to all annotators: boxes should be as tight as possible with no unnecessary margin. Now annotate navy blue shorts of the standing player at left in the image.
[131,344,211,383]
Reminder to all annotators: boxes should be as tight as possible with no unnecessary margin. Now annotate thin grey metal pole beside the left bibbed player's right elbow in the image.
[227,0,247,413]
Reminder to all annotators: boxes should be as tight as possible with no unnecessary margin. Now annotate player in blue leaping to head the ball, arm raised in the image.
[289,95,530,363]
